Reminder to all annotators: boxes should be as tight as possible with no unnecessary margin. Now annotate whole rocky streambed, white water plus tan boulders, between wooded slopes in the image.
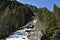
[1,19,43,40]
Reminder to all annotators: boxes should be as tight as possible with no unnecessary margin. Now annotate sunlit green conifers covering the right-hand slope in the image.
[37,4,60,40]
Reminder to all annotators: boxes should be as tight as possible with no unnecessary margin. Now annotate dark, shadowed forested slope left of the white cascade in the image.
[0,0,34,38]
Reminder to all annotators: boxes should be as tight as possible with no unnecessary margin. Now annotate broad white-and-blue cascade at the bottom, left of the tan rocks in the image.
[6,28,31,40]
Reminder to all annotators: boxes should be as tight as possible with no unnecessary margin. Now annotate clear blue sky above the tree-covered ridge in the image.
[17,0,60,11]
